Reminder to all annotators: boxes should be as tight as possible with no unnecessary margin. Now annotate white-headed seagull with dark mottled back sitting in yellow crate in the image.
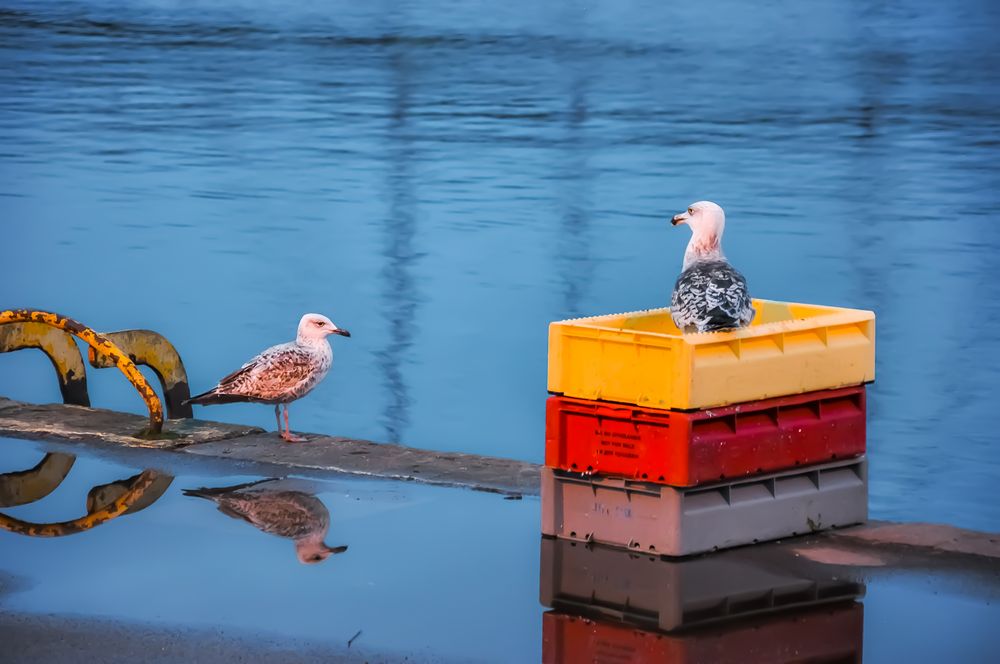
[670,201,756,333]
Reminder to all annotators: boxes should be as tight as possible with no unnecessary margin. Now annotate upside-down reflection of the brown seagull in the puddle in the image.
[184,479,347,565]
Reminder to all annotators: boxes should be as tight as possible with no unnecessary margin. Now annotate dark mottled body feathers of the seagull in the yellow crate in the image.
[670,260,755,332]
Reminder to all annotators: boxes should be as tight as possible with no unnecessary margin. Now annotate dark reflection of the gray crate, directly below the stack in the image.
[539,537,865,632]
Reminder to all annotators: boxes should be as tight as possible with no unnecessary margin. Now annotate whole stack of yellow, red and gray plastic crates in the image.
[542,300,875,556]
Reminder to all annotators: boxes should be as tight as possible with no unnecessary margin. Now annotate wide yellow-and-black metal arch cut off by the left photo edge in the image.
[0,323,90,406]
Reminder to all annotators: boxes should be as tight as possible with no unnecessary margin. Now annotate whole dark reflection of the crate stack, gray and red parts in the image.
[541,539,865,664]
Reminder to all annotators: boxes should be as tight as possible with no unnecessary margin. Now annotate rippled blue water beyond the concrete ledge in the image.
[0,0,1000,530]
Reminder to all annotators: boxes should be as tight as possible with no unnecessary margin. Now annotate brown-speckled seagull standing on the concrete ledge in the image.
[184,314,351,443]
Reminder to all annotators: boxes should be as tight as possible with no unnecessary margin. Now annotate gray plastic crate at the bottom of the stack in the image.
[542,457,868,556]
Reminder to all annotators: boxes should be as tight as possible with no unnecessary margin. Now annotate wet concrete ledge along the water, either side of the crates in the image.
[0,397,1000,560]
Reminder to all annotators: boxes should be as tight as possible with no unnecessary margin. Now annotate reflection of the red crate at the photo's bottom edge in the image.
[542,602,864,664]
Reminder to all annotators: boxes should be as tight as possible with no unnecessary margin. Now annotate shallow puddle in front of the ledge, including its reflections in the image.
[0,440,1000,662]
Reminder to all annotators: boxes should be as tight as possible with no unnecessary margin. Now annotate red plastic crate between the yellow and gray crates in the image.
[545,385,865,486]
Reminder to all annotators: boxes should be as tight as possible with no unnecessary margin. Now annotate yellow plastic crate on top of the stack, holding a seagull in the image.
[549,300,875,410]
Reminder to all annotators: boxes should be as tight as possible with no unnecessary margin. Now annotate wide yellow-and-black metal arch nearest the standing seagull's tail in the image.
[87,330,194,419]
